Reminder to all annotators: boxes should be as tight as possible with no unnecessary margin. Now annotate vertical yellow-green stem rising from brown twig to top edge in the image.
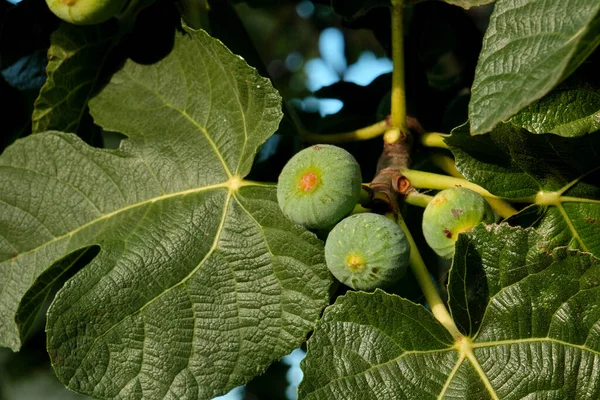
[384,0,408,143]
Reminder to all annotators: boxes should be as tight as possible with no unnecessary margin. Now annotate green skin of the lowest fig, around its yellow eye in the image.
[325,213,410,290]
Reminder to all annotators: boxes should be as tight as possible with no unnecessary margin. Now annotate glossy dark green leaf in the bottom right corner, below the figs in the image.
[299,225,600,400]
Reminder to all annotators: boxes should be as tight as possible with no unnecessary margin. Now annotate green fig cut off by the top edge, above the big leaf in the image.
[46,0,129,25]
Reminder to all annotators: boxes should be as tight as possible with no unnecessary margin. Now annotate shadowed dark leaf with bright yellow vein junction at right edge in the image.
[445,123,600,256]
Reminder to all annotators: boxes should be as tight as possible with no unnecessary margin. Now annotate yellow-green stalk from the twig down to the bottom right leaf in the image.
[396,214,463,340]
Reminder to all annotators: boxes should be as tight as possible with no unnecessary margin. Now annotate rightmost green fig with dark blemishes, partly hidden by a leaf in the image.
[423,188,495,259]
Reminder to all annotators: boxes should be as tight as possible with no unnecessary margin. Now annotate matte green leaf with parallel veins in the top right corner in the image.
[469,0,600,134]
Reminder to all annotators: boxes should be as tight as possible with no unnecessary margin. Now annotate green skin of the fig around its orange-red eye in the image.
[277,144,362,229]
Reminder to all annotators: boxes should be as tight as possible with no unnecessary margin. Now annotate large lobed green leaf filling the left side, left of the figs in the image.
[0,31,331,399]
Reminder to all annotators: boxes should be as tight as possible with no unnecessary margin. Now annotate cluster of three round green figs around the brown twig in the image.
[277,145,494,290]
